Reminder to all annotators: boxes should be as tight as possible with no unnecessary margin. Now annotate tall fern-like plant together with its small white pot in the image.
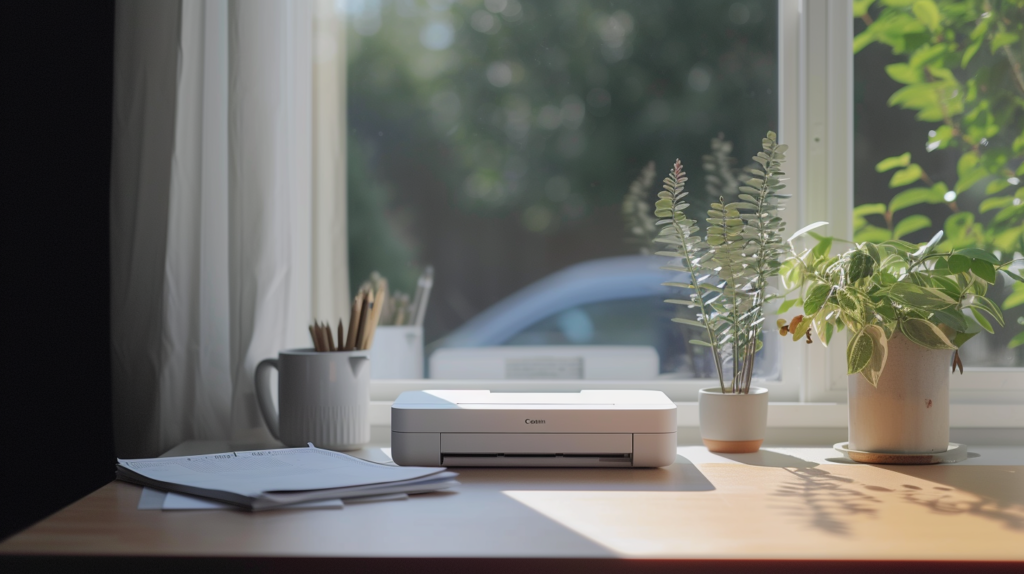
[654,132,788,452]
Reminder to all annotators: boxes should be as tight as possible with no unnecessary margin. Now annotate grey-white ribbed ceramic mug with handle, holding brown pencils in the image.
[256,349,370,450]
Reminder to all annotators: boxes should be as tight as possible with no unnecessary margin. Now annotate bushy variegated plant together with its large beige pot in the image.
[777,231,1024,454]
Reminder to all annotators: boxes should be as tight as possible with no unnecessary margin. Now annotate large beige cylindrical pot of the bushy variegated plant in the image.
[849,332,952,454]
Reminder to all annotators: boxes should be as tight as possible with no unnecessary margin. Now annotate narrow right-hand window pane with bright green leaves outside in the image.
[854,0,1024,367]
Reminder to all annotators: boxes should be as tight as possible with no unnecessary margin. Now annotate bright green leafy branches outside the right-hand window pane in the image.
[854,0,1024,259]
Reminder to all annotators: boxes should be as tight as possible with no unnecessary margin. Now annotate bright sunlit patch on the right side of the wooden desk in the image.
[503,454,1024,560]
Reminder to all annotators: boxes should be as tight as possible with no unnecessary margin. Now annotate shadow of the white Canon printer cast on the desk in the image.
[453,454,715,492]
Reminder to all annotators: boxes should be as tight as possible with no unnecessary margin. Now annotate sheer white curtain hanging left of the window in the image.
[111,0,348,457]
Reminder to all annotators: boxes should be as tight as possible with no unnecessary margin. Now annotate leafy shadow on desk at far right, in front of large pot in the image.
[886,465,1024,531]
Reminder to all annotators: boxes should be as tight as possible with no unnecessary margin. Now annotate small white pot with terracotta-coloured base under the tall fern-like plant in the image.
[697,387,768,452]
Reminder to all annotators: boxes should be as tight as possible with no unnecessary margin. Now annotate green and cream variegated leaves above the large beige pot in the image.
[778,223,1024,386]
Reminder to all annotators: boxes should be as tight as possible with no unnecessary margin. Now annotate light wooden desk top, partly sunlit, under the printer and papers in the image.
[0,443,1024,572]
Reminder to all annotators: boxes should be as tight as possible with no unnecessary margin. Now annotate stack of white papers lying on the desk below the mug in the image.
[117,444,459,511]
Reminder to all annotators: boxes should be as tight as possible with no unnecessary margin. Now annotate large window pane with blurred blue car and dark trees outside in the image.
[343,0,777,377]
